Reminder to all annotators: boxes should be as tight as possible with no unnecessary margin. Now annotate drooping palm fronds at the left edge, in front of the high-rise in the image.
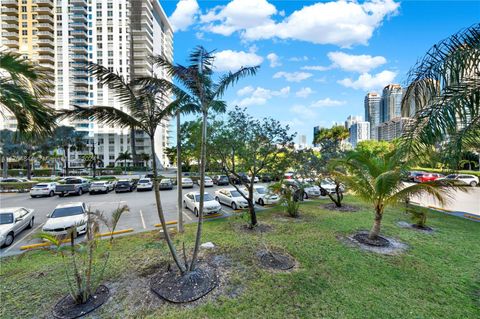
[0,52,55,134]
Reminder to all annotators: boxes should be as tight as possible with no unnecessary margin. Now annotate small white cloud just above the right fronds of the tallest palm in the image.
[214,50,263,71]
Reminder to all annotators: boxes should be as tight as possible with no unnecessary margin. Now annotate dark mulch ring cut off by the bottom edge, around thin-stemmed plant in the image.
[52,285,110,319]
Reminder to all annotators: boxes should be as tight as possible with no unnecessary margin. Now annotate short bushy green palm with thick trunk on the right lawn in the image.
[333,151,452,240]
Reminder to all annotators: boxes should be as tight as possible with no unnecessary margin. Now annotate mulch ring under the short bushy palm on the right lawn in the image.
[339,231,408,255]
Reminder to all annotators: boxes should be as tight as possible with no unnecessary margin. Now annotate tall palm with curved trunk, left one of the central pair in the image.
[60,64,186,274]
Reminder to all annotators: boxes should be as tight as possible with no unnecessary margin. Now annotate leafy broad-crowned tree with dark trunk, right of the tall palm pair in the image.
[212,107,294,228]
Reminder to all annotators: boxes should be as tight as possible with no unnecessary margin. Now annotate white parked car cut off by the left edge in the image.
[0,207,35,247]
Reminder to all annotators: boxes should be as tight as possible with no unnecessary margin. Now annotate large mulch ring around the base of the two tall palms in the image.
[150,263,218,303]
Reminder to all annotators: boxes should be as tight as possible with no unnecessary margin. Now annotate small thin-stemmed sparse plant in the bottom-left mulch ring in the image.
[38,205,128,304]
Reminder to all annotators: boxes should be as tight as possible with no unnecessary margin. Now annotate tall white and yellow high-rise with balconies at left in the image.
[0,0,173,167]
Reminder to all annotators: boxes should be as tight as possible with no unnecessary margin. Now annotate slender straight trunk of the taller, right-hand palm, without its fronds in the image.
[190,110,208,271]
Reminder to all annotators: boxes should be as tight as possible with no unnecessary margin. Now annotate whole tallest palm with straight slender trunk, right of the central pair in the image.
[155,46,259,271]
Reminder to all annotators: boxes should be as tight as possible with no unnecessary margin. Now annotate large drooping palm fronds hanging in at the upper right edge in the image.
[402,24,480,167]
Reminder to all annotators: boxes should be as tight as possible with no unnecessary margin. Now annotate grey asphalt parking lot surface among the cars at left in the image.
[0,185,274,256]
